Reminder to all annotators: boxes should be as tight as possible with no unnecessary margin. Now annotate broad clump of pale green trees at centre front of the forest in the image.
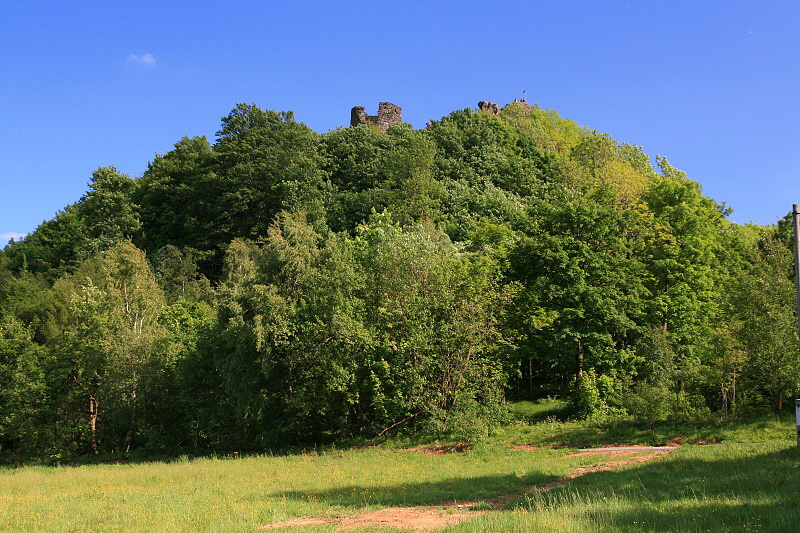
[206,213,503,442]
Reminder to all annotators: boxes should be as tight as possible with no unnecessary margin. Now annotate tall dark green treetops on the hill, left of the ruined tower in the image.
[136,104,327,272]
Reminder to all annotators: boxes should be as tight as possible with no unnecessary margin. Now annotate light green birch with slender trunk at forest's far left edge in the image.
[0,243,166,456]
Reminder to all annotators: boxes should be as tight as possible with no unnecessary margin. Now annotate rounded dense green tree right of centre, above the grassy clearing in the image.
[510,187,647,392]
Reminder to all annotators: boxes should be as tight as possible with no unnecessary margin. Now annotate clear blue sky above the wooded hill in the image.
[0,0,800,246]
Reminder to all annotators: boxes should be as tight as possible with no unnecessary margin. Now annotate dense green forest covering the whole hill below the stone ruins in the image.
[0,102,800,458]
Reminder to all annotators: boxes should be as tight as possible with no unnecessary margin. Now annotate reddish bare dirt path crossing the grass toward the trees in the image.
[259,446,676,531]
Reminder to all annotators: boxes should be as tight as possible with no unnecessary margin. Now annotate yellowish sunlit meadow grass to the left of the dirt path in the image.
[0,449,587,532]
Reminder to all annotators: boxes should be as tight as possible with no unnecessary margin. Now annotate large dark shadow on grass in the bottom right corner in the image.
[520,444,800,531]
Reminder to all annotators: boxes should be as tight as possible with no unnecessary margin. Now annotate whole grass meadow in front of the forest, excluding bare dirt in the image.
[0,406,800,533]
